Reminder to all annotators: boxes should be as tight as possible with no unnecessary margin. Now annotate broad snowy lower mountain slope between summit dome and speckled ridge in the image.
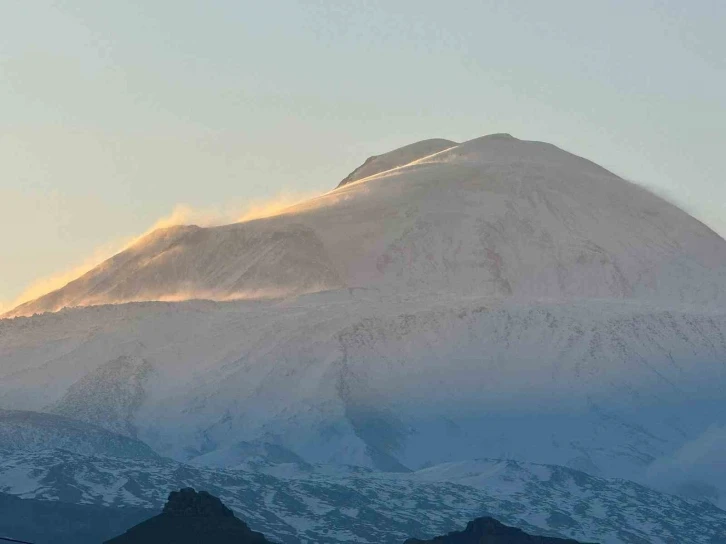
[0,298,726,501]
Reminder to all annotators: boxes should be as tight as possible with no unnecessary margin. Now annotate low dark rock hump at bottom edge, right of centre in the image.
[405,518,600,544]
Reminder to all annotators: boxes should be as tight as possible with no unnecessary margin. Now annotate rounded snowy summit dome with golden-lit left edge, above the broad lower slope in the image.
[7,134,726,316]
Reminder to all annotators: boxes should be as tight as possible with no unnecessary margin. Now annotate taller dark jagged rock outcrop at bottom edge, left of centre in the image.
[106,488,268,544]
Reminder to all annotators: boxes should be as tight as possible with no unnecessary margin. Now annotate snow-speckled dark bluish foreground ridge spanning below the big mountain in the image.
[0,450,726,544]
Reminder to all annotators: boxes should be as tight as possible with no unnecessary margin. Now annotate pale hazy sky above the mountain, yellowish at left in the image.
[0,0,726,306]
